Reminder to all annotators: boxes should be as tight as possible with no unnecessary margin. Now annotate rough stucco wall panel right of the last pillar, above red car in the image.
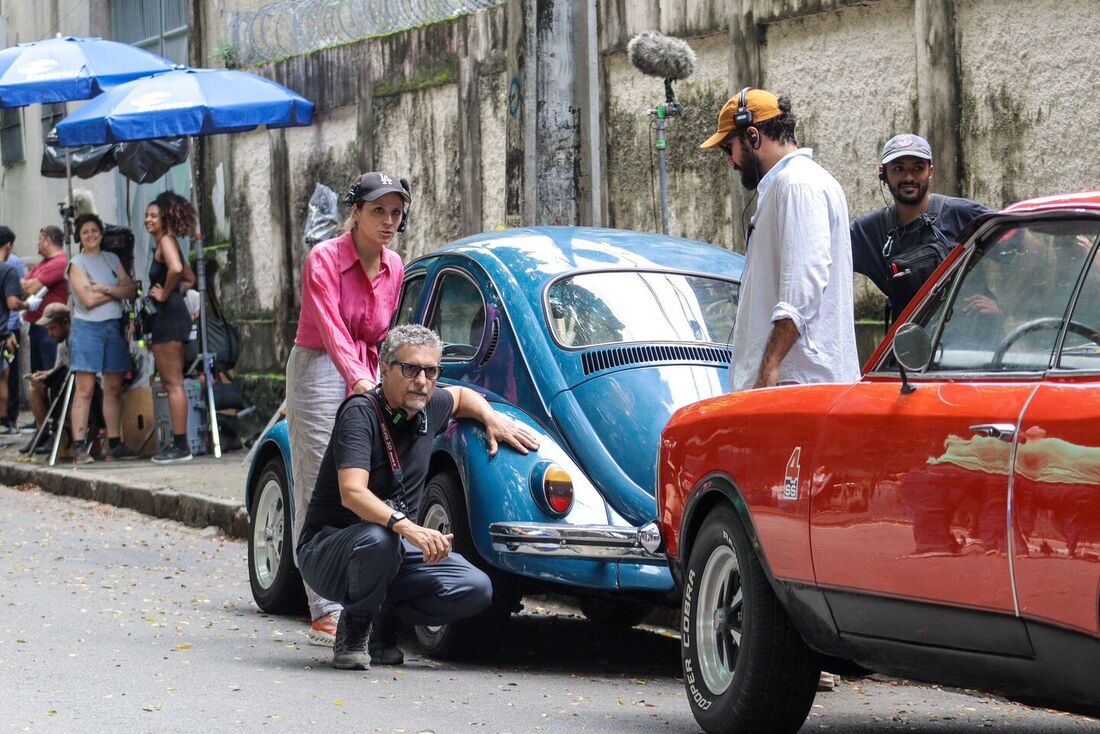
[956,0,1100,206]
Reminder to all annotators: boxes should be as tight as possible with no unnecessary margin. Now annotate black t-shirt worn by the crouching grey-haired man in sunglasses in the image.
[298,388,454,547]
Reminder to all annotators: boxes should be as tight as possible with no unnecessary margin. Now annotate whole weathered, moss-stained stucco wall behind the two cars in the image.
[206,0,1100,369]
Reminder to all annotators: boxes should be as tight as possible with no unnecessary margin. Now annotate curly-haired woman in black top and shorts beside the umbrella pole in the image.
[145,191,198,463]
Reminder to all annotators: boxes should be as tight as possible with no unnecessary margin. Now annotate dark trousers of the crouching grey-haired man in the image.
[298,523,493,625]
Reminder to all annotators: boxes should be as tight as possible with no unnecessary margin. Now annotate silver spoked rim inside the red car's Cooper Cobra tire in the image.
[694,546,745,695]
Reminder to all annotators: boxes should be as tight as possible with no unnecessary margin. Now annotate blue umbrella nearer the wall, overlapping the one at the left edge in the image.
[57,68,314,146]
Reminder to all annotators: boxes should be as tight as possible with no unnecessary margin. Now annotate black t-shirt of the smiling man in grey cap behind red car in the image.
[851,194,989,301]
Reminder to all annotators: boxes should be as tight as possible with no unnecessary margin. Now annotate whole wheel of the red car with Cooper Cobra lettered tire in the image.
[680,506,821,734]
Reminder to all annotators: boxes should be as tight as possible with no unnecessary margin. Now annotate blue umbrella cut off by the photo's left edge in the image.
[0,37,178,107]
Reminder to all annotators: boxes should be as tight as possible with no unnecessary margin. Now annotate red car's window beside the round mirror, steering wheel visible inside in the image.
[928,220,1089,372]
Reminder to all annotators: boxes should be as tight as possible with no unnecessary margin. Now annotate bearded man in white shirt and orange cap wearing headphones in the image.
[701,87,859,392]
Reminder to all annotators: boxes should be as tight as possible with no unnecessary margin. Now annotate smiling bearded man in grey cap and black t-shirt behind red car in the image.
[851,133,989,321]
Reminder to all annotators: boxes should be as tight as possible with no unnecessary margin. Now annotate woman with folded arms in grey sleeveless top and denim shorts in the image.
[67,215,134,464]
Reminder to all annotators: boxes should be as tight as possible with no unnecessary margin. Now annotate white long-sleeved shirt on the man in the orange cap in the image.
[729,147,859,392]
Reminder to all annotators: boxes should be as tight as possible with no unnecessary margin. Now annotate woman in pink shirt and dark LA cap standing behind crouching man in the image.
[286,172,411,646]
